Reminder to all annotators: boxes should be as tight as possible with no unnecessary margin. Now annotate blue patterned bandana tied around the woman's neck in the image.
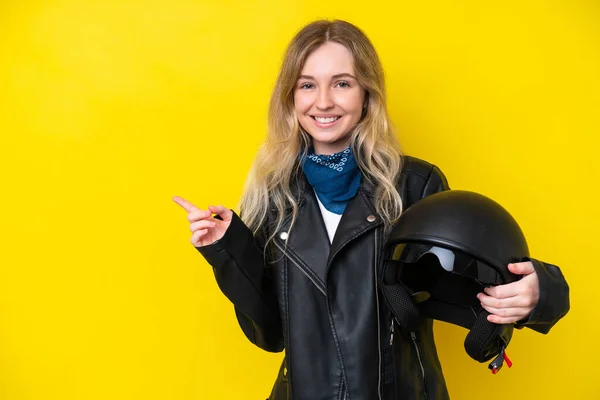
[301,146,360,215]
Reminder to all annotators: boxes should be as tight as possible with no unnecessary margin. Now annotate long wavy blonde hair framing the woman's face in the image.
[239,20,402,241]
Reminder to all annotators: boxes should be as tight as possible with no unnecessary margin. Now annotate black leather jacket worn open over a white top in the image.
[198,157,569,400]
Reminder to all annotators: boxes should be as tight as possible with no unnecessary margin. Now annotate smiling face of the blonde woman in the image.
[294,42,365,154]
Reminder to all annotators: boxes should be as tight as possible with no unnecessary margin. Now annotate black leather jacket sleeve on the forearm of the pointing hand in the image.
[196,212,283,352]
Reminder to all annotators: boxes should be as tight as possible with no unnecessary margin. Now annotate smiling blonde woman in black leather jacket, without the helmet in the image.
[175,21,568,400]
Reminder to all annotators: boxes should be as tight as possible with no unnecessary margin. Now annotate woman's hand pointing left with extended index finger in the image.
[173,196,233,247]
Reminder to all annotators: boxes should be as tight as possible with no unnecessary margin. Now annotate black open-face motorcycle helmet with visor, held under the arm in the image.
[383,190,529,373]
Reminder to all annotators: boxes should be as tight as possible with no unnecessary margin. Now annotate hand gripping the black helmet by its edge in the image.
[477,261,540,324]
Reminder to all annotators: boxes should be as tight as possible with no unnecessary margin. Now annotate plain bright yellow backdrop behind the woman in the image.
[0,0,600,400]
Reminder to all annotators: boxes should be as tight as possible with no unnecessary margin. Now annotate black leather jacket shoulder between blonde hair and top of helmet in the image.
[397,155,450,208]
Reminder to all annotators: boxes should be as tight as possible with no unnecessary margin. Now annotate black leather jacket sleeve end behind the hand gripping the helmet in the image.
[515,257,571,334]
